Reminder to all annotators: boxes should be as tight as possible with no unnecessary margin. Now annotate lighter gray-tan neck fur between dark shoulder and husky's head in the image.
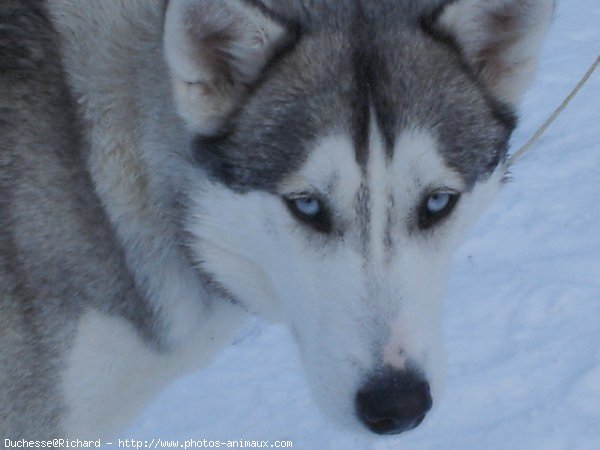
[43,0,245,350]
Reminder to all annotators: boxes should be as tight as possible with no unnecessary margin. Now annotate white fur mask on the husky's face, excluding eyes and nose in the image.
[188,122,503,429]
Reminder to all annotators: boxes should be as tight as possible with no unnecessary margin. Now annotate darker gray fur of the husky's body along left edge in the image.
[0,0,154,439]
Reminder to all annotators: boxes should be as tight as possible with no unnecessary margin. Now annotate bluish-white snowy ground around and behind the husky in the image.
[127,0,600,450]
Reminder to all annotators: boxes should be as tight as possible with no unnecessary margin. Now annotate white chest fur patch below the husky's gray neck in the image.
[61,301,245,439]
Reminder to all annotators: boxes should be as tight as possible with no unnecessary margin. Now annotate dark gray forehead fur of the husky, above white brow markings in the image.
[204,9,512,192]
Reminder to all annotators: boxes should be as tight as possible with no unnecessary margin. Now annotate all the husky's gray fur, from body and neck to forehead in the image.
[0,0,552,439]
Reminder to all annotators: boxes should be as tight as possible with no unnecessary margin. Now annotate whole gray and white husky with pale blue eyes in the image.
[0,0,554,439]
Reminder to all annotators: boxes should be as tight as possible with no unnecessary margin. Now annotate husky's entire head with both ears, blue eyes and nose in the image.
[165,0,553,433]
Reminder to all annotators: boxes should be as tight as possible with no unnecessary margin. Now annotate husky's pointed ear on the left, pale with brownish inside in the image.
[164,0,289,135]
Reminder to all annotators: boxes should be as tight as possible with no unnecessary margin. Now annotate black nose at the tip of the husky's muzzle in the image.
[356,371,432,434]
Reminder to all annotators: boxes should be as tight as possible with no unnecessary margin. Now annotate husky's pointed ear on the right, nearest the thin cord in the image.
[434,0,554,107]
